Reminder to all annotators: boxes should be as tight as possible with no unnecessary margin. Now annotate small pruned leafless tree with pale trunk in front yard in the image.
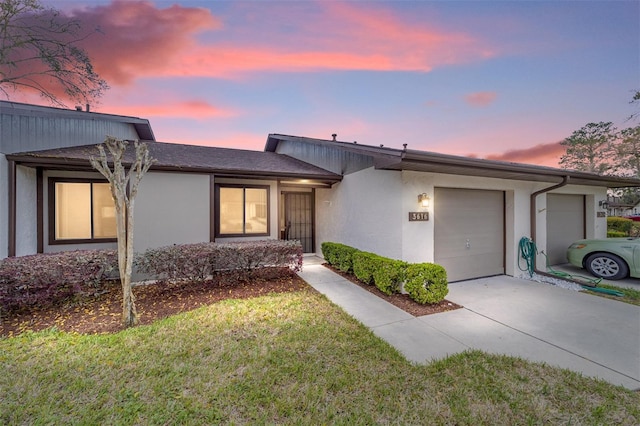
[90,136,155,327]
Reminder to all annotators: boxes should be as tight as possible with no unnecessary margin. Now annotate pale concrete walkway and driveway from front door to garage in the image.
[299,257,640,389]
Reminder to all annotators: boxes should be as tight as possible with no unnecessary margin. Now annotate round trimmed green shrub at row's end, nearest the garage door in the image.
[404,263,449,304]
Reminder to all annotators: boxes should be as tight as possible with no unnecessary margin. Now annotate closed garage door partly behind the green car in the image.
[546,194,585,265]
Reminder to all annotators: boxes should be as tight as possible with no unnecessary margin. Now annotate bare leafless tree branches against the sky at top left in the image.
[0,0,109,106]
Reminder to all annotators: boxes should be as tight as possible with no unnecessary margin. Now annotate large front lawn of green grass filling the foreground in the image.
[0,291,640,425]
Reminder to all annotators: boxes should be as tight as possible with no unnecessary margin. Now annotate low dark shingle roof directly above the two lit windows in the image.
[7,141,342,183]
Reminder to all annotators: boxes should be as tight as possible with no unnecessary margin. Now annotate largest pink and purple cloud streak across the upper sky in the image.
[67,0,495,85]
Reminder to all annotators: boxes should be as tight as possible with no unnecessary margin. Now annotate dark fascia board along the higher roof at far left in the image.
[0,101,156,141]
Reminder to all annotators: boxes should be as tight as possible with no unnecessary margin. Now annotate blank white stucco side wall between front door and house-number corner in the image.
[316,168,404,259]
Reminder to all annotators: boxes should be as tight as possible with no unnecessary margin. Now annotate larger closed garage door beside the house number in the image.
[433,188,504,281]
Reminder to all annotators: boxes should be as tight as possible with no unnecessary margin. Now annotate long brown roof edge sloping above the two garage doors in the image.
[265,134,640,188]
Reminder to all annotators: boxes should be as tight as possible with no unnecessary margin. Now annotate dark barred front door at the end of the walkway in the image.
[283,192,314,253]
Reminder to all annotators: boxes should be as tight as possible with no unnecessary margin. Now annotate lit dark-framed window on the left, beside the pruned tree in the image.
[49,179,116,244]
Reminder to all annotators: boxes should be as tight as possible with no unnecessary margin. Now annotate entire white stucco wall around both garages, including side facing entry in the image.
[316,168,607,276]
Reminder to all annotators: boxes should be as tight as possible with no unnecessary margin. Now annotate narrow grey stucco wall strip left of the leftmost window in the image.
[16,166,38,256]
